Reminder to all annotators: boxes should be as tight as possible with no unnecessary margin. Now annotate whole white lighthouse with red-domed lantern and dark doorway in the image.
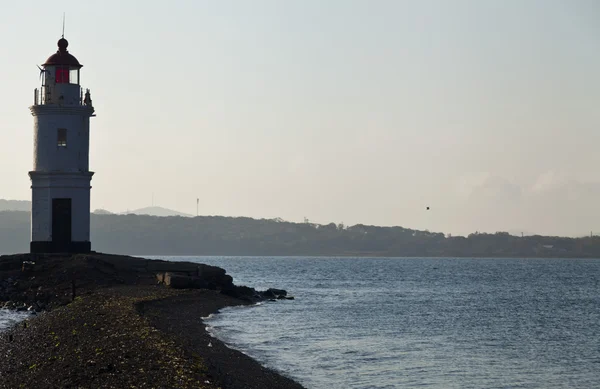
[29,37,95,253]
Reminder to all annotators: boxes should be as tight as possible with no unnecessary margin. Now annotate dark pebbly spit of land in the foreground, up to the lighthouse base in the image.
[0,254,303,389]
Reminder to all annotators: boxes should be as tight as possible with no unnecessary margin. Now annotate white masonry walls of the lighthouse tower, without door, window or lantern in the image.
[29,101,94,242]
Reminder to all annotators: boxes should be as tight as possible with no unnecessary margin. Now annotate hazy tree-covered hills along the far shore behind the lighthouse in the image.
[0,211,600,258]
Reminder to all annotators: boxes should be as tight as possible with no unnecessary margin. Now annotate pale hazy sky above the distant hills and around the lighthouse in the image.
[0,0,600,235]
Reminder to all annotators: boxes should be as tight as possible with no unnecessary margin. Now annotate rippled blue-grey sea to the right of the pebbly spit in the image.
[154,257,600,389]
